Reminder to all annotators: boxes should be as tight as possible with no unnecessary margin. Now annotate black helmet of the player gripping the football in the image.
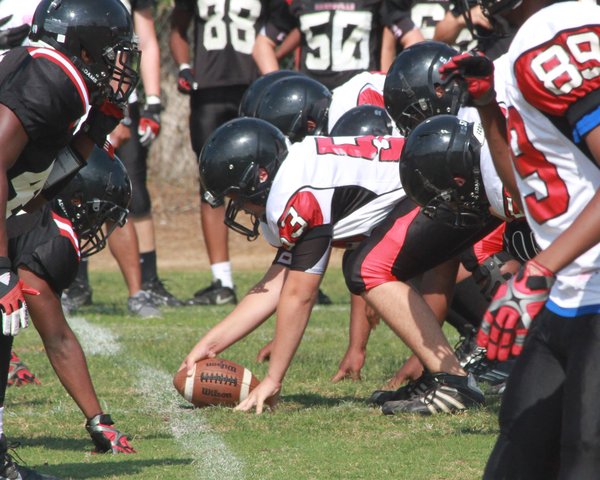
[199,117,287,240]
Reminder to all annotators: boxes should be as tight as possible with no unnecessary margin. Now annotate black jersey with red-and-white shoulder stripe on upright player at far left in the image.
[0,47,89,217]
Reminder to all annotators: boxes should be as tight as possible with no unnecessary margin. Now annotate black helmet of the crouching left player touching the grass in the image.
[52,145,131,257]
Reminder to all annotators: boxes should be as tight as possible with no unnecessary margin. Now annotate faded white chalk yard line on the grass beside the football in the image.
[69,316,245,480]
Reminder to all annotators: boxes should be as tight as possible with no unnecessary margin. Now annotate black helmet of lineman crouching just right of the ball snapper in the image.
[400,115,489,228]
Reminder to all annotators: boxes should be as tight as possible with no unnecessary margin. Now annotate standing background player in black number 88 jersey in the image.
[169,0,287,305]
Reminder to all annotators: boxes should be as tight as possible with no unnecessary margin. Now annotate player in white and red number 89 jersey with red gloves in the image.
[436,0,600,479]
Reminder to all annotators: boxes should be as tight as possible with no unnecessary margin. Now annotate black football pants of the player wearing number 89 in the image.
[483,309,600,480]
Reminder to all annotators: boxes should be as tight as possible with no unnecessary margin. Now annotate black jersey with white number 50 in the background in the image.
[265,0,414,89]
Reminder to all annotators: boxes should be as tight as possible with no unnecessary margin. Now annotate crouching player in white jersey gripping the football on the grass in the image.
[180,118,492,413]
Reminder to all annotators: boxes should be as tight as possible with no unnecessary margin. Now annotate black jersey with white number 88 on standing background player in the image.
[175,0,287,88]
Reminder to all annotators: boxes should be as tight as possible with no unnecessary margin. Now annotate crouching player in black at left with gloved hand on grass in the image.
[0,147,134,479]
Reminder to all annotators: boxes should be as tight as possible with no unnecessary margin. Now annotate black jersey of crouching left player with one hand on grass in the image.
[8,204,80,295]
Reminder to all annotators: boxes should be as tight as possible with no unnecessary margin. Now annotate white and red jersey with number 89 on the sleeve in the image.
[506,2,600,316]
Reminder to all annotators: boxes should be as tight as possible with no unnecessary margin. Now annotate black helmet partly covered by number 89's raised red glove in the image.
[383,41,464,136]
